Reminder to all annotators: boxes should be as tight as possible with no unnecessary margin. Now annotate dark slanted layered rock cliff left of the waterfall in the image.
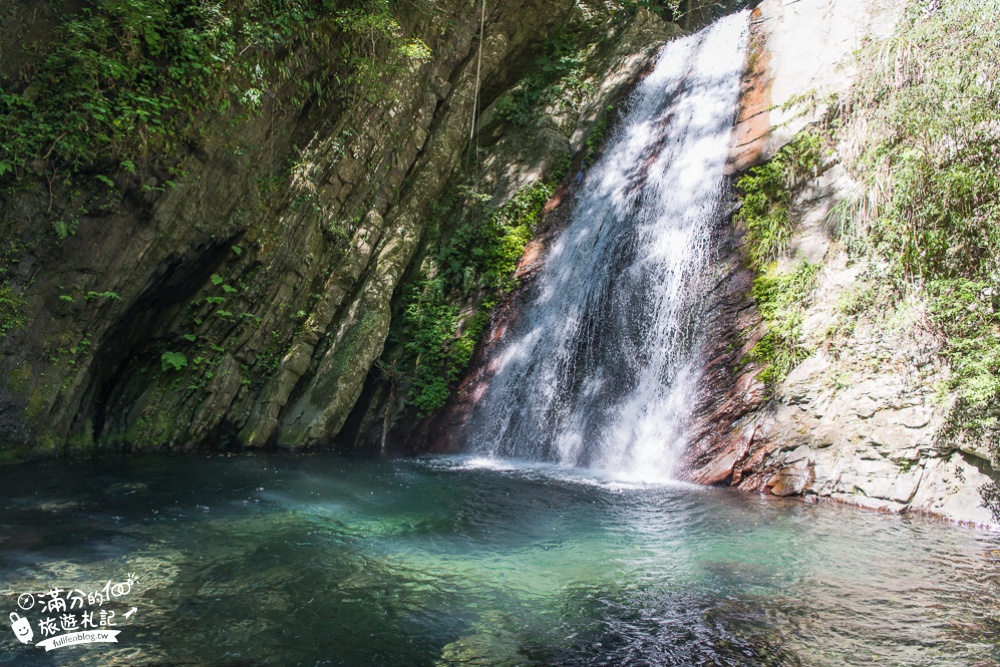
[0,0,692,460]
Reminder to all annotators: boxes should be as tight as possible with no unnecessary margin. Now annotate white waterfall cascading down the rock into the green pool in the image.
[469,12,747,480]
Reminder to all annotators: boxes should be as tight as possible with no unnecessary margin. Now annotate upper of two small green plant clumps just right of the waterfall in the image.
[736,132,824,269]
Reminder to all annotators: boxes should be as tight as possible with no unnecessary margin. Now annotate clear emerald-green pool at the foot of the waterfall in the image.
[0,455,1000,666]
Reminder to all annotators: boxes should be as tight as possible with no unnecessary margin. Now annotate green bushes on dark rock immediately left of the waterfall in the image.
[402,183,553,417]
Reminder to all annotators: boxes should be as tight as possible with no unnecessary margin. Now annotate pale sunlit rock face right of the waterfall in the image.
[685,0,996,524]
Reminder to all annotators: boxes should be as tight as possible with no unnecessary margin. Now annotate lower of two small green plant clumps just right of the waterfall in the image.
[744,261,819,387]
